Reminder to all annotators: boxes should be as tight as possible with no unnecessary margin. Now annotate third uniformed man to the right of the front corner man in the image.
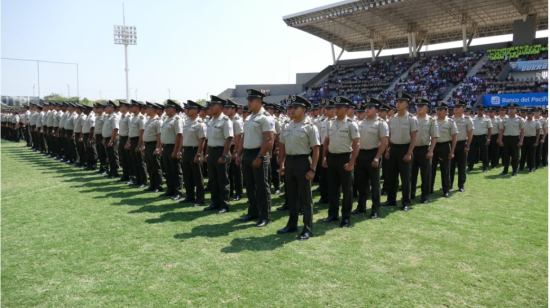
[381,92,418,211]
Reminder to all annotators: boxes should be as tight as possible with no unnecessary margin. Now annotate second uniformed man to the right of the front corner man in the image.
[351,97,389,219]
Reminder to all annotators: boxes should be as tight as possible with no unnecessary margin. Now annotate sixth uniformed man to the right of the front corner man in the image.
[451,99,474,192]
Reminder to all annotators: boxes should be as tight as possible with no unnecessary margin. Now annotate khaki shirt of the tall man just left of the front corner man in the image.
[244,107,275,149]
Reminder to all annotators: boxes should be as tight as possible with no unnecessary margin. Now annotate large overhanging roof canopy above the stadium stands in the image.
[283,0,548,52]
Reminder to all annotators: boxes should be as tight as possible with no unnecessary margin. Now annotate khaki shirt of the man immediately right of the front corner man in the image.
[327,116,361,154]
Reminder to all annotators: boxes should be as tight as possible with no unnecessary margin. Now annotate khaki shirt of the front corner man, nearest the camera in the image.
[279,118,321,155]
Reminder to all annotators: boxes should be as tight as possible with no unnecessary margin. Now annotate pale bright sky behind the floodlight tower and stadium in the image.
[1,0,547,101]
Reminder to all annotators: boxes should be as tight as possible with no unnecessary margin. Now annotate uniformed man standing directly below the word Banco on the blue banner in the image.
[498,103,525,176]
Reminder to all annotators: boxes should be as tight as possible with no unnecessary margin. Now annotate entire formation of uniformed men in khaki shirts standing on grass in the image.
[10,94,548,240]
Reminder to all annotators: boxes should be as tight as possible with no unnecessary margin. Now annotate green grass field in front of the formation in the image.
[1,141,548,307]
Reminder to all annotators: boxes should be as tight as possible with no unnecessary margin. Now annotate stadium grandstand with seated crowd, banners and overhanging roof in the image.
[220,0,548,108]
